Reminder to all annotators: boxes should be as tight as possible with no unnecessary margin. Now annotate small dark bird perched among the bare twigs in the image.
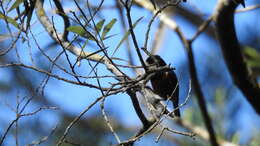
[146,55,181,117]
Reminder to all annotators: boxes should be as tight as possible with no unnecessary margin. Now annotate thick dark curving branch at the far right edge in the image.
[215,0,260,114]
